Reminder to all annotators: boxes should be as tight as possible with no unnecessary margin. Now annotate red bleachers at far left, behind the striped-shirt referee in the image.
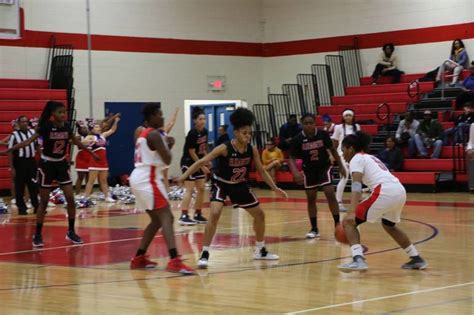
[0,79,67,189]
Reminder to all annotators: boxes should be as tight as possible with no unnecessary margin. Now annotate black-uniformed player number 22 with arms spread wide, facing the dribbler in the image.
[178,108,288,268]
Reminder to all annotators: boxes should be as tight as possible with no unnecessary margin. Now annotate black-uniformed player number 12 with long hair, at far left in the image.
[1,101,98,247]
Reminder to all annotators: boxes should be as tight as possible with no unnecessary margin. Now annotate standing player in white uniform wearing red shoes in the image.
[130,103,194,274]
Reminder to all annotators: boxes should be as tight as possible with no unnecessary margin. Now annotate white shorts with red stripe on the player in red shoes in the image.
[129,166,169,210]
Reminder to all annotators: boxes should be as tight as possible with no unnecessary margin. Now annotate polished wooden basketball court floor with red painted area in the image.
[0,190,474,314]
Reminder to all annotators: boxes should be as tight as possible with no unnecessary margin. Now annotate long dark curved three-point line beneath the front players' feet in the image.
[0,218,439,292]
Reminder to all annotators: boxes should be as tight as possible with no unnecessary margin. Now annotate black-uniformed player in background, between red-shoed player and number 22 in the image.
[178,107,210,225]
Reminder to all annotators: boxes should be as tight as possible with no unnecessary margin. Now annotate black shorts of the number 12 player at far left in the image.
[37,160,72,188]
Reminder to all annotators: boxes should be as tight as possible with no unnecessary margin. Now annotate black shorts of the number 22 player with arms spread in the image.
[210,178,260,209]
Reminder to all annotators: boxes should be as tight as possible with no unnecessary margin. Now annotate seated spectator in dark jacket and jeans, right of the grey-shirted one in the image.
[415,110,443,159]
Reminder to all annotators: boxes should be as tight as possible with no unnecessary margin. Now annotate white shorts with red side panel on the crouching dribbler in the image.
[356,183,407,223]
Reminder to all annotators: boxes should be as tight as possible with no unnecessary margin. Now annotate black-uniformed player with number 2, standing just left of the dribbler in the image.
[289,113,346,239]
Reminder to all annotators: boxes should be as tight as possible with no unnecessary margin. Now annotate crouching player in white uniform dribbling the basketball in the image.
[338,132,427,272]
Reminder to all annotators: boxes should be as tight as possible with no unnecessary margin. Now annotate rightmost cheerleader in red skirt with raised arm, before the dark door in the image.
[85,117,120,203]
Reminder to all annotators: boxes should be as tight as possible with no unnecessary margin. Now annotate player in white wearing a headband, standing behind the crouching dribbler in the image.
[331,109,360,212]
